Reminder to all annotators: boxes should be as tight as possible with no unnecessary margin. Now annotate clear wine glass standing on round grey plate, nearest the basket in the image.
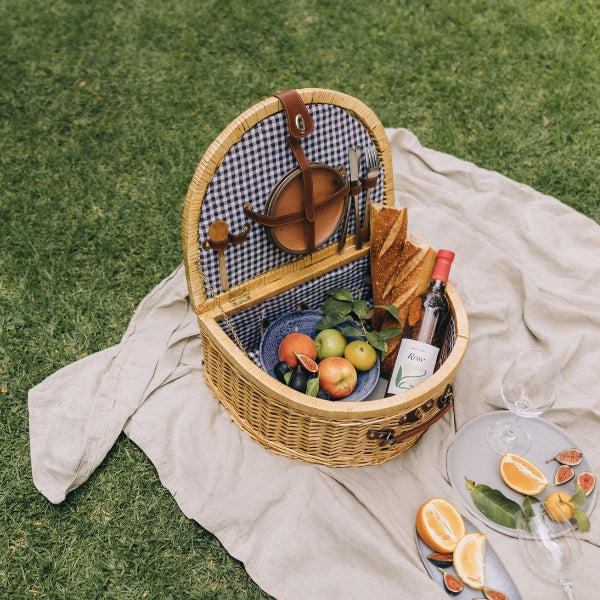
[487,348,560,455]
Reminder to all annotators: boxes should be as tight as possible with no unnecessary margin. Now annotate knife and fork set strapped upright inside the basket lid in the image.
[337,146,381,252]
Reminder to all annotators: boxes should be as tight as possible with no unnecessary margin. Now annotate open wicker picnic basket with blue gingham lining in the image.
[183,88,469,466]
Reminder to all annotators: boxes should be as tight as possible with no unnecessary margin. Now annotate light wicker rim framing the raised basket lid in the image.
[182,88,394,315]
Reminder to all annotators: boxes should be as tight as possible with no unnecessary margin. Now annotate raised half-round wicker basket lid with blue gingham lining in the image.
[182,88,394,314]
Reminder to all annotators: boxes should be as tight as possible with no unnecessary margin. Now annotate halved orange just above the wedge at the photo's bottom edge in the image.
[417,498,465,553]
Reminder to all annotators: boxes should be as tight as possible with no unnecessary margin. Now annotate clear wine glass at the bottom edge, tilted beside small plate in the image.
[517,502,583,600]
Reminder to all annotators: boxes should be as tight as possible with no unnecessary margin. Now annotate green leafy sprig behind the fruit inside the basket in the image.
[317,288,402,360]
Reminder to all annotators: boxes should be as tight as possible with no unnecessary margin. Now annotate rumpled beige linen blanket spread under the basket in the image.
[29,129,600,600]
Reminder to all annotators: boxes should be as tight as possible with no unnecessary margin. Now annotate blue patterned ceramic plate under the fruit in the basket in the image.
[259,310,379,402]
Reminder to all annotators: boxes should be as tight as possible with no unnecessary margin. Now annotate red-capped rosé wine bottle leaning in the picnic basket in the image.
[386,250,454,396]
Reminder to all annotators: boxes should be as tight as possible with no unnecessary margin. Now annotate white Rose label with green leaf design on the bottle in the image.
[387,338,440,394]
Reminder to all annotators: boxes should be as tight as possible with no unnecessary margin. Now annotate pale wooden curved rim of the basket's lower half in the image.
[198,281,470,422]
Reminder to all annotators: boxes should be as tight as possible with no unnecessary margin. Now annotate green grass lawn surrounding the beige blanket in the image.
[0,0,600,599]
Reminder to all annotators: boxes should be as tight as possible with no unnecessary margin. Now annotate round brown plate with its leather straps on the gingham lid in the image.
[243,90,349,254]
